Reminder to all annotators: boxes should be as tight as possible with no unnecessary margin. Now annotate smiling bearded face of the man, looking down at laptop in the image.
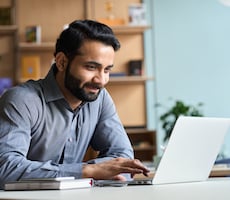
[64,41,115,101]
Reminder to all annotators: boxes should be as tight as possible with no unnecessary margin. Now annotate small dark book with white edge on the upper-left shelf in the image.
[25,26,41,43]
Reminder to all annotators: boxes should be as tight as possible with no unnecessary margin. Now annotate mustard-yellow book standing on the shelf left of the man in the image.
[21,56,40,79]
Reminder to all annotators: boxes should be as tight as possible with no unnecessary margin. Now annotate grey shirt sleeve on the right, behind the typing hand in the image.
[90,90,134,163]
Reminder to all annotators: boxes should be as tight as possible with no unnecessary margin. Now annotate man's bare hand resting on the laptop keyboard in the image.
[82,158,149,181]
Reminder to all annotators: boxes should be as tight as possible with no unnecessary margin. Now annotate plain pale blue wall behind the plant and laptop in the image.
[146,0,230,157]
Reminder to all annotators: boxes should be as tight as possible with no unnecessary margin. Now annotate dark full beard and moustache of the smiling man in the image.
[64,64,102,102]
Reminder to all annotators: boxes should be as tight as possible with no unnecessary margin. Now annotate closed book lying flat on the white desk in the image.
[4,177,93,191]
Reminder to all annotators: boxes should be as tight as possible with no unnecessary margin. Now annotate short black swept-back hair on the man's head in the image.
[54,20,120,61]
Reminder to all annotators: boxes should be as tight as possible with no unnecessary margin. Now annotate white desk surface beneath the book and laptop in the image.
[0,178,230,200]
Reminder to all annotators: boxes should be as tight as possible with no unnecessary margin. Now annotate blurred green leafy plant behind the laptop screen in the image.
[160,100,203,142]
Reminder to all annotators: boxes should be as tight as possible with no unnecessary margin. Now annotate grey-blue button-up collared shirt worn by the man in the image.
[0,67,133,188]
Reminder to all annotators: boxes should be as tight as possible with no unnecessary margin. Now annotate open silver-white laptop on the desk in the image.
[95,116,230,186]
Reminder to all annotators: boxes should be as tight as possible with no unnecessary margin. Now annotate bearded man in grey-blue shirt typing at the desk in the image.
[0,20,148,188]
